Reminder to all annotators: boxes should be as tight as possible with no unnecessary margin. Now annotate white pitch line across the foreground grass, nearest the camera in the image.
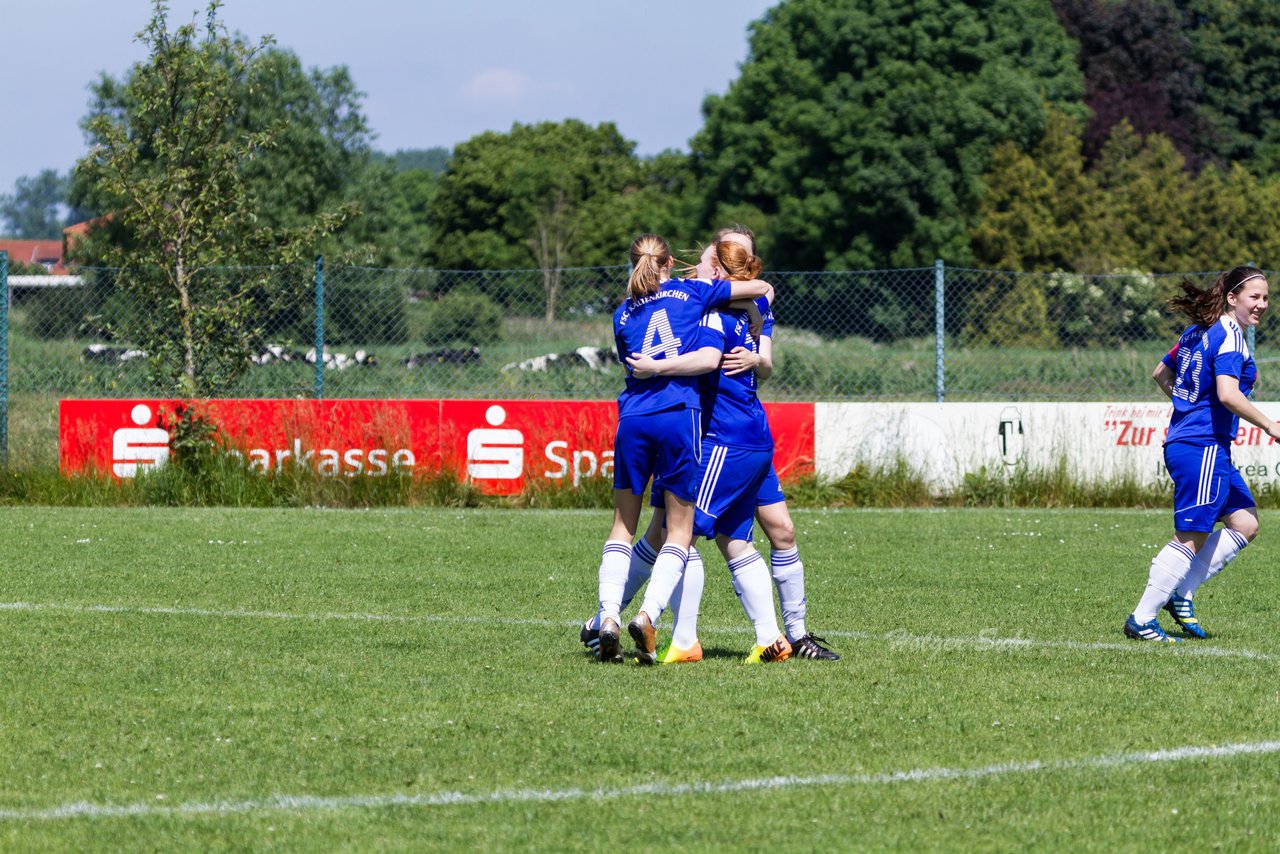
[0,741,1280,822]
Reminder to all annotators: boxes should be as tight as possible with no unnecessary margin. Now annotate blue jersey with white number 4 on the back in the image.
[613,279,732,419]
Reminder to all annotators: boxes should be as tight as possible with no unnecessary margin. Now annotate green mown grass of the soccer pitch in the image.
[0,507,1280,851]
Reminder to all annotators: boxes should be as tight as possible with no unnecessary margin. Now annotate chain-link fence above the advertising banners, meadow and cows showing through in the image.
[0,255,1267,461]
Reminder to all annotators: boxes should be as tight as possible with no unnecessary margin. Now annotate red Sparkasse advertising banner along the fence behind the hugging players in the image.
[59,399,814,495]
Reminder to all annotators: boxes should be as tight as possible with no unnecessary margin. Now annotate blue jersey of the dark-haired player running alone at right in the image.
[1161,315,1258,447]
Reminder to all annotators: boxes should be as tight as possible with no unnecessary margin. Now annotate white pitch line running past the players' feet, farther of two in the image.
[0,602,1277,661]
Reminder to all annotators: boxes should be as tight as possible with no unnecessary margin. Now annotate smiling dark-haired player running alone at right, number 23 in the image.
[1124,266,1280,643]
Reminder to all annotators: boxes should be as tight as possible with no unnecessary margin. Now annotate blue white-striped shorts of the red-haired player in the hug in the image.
[694,440,773,540]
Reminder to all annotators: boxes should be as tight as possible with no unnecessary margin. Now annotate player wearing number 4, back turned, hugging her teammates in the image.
[599,234,773,665]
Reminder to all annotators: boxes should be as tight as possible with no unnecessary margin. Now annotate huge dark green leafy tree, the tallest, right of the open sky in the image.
[692,0,1083,275]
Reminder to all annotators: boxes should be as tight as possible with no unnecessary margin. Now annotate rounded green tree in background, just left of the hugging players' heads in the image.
[430,119,644,320]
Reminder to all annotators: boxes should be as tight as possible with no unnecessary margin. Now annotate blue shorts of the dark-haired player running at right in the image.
[1165,442,1257,533]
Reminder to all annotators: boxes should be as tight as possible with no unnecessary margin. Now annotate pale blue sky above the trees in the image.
[0,0,777,193]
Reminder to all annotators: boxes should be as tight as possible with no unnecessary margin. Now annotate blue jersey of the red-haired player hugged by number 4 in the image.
[701,297,773,451]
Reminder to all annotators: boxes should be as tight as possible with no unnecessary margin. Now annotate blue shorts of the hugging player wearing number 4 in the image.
[613,407,700,502]
